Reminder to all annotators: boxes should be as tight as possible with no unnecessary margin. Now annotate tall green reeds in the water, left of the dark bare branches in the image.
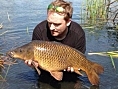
[82,0,107,26]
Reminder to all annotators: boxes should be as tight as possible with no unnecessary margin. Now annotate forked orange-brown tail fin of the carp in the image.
[86,63,104,85]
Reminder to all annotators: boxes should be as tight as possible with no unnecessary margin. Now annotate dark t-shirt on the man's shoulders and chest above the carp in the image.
[32,20,86,53]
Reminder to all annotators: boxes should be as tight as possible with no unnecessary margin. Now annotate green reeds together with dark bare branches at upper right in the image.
[82,0,118,27]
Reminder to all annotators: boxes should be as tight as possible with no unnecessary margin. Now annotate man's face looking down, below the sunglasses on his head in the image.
[47,12,70,36]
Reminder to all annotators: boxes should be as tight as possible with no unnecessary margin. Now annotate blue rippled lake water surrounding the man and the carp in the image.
[0,0,118,89]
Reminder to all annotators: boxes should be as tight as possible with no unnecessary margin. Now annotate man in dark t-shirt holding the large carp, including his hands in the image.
[25,0,86,88]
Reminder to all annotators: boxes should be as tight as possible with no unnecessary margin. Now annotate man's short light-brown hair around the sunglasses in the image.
[47,0,73,21]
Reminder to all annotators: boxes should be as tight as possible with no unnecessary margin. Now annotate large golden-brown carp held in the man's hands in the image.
[6,40,104,85]
